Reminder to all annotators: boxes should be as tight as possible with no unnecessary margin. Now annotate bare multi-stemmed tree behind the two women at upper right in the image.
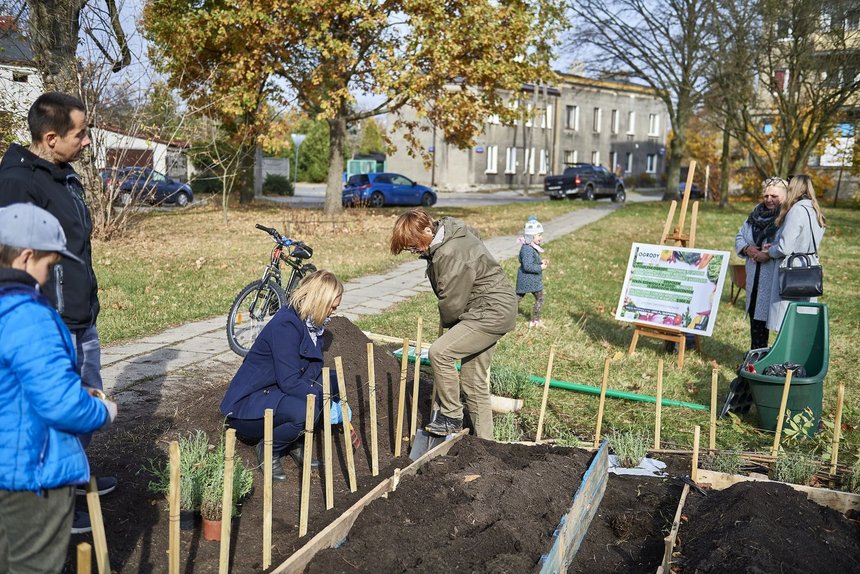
[713,0,860,177]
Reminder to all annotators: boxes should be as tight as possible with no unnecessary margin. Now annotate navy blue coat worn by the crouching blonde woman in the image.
[221,306,337,423]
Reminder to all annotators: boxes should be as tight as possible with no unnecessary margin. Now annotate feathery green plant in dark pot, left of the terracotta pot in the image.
[144,430,211,530]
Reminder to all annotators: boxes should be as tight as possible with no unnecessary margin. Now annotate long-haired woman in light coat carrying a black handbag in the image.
[765,175,825,331]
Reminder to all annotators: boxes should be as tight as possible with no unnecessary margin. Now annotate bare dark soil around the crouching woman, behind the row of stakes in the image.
[66,318,420,574]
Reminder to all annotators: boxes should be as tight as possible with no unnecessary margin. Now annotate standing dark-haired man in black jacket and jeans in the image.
[0,92,116,532]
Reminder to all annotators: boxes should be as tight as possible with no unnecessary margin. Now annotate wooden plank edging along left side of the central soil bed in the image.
[270,429,469,574]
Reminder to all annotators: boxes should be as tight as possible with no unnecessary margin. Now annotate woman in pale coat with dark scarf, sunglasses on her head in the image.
[735,177,788,349]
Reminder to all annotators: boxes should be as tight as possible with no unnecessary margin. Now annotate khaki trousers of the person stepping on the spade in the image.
[429,321,502,440]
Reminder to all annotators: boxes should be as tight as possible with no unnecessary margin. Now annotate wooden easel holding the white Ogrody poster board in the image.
[627,161,702,369]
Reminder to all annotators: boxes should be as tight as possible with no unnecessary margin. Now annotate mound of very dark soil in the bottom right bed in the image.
[678,482,860,574]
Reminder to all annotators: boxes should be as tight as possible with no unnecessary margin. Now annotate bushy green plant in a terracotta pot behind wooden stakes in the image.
[200,441,254,540]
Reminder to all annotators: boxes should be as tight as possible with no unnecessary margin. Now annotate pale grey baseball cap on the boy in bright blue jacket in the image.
[0,203,83,263]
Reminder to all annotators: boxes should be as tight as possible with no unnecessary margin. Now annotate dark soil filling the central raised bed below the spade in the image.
[307,436,592,574]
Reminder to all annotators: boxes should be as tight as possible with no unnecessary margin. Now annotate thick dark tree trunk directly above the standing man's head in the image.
[27,0,87,96]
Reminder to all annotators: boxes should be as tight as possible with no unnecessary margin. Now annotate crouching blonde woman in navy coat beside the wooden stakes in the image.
[221,270,343,480]
